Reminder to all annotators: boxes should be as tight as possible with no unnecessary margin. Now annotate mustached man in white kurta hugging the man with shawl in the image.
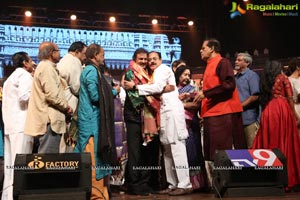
[125,52,192,195]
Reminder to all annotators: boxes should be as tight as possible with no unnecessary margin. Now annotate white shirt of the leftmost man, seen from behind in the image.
[2,68,33,135]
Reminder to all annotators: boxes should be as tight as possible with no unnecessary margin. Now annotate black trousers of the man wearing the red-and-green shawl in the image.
[125,122,159,192]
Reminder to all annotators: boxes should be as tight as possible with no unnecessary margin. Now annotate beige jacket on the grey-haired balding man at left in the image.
[24,60,68,136]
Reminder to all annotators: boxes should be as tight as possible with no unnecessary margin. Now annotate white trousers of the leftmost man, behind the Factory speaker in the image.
[1,133,33,200]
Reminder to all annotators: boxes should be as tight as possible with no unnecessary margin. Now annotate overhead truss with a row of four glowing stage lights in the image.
[4,7,196,32]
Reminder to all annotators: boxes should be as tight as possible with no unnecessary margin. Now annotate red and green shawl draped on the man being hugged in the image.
[125,61,160,146]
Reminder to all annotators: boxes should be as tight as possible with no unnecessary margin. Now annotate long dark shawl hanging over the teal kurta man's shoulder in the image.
[88,60,117,166]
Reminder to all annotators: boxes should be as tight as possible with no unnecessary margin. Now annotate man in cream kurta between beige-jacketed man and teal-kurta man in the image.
[57,41,87,153]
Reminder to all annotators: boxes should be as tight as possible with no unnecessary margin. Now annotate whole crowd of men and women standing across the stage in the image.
[0,38,300,200]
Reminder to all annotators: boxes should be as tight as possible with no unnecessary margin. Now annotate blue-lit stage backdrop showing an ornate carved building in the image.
[0,24,181,78]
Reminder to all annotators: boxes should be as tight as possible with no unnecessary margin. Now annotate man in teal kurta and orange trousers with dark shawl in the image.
[74,44,117,200]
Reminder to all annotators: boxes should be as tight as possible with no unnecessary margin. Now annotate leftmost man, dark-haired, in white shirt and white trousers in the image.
[2,52,34,200]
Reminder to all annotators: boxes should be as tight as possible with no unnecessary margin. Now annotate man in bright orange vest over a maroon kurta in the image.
[194,39,247,188]
